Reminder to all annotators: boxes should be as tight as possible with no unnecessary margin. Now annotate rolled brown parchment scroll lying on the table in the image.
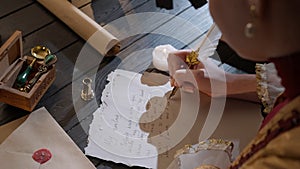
[37,0,120,56]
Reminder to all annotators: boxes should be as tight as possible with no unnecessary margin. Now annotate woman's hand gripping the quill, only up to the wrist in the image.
[168,50,227,97]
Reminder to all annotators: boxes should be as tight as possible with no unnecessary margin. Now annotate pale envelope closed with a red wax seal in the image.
[0,108,95,169]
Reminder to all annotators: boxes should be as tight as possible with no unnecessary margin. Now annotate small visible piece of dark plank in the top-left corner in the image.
[0,0,33,18]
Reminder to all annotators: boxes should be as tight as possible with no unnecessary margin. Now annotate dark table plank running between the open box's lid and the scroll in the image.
[0,4,54,40]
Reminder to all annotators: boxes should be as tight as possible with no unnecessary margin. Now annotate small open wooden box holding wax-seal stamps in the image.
[0,31,56,111]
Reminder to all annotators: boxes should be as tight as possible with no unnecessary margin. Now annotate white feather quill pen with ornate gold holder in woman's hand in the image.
[169,23,221,99]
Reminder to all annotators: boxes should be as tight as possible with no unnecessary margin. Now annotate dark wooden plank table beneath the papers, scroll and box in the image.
[0,0,260,169]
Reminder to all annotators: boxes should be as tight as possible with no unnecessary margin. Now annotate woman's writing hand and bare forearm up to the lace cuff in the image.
[168,50,258,102]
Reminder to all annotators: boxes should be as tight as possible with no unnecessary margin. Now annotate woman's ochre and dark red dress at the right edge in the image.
[230,53,300,169]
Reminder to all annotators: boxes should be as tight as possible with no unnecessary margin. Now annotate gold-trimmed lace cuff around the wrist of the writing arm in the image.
[255,63,284,114]
